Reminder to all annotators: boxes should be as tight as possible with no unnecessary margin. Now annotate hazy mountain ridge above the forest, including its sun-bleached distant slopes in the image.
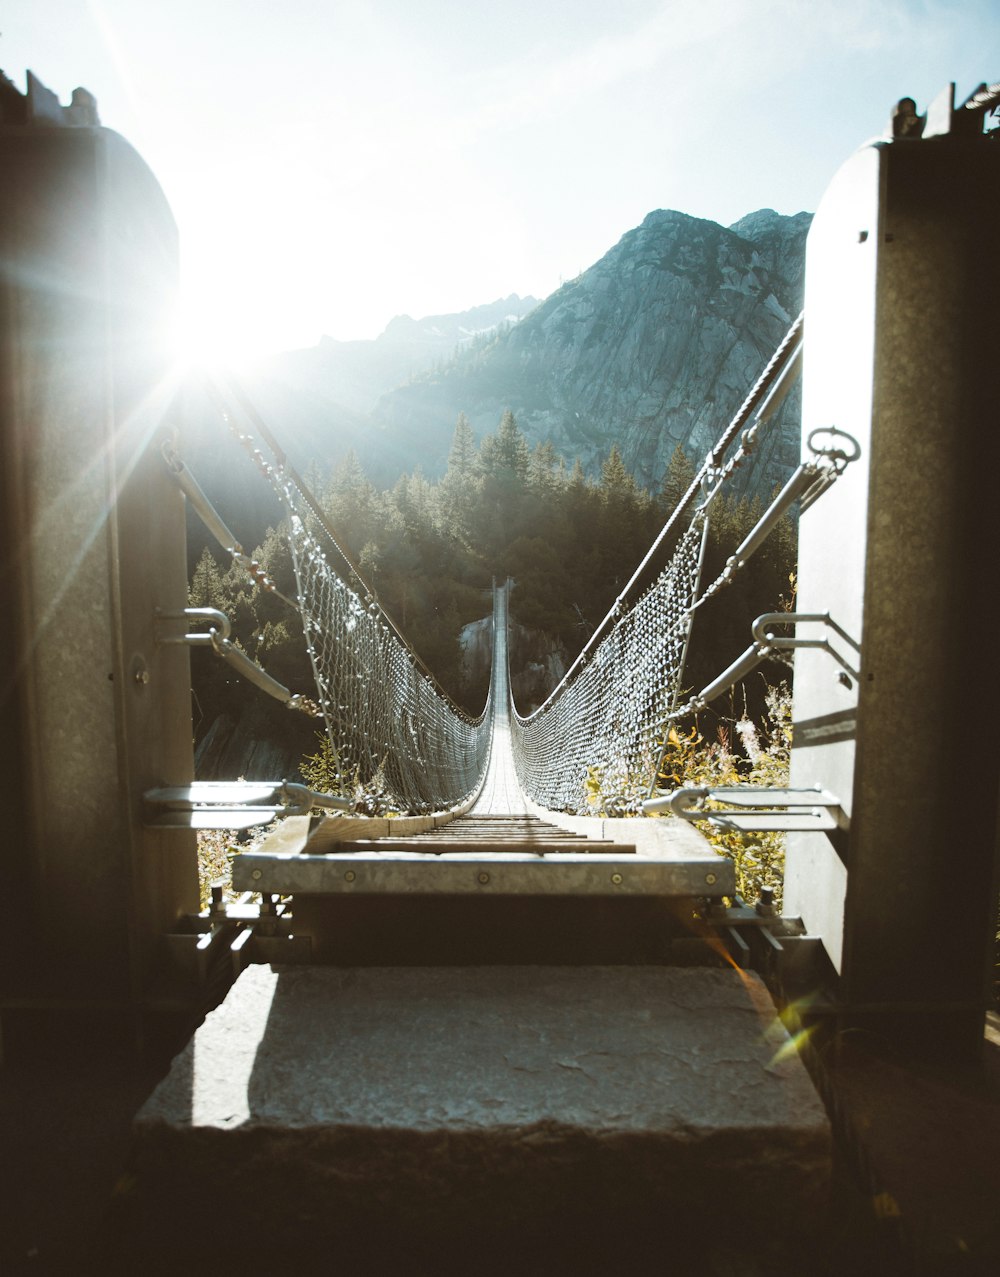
[236,208,812,490]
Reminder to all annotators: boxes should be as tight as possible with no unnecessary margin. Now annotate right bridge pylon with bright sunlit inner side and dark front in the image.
[784,92,1000,1056]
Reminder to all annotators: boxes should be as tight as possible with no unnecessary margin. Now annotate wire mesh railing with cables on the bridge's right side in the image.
[511,315,853,811]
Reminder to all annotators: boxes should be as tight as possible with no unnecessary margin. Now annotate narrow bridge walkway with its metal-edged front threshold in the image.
[234,586,734,893]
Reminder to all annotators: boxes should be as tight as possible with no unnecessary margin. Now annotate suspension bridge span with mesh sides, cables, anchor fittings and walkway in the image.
[134,317,837,929]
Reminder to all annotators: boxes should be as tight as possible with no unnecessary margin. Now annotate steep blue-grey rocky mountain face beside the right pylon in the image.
[369,209,811,487]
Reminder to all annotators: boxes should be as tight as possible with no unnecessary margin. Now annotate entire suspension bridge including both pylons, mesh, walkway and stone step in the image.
[0,74,1000,1273]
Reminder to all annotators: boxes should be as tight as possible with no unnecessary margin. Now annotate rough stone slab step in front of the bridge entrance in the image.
[132,967,830,1274]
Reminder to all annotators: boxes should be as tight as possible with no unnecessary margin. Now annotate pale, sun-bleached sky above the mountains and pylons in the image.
[0,0,1000,352]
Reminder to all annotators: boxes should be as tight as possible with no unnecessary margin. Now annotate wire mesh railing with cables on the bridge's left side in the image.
[174,372,490,812]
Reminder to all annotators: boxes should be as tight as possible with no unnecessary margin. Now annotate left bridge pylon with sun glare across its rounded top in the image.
[0,99,197,1047]
